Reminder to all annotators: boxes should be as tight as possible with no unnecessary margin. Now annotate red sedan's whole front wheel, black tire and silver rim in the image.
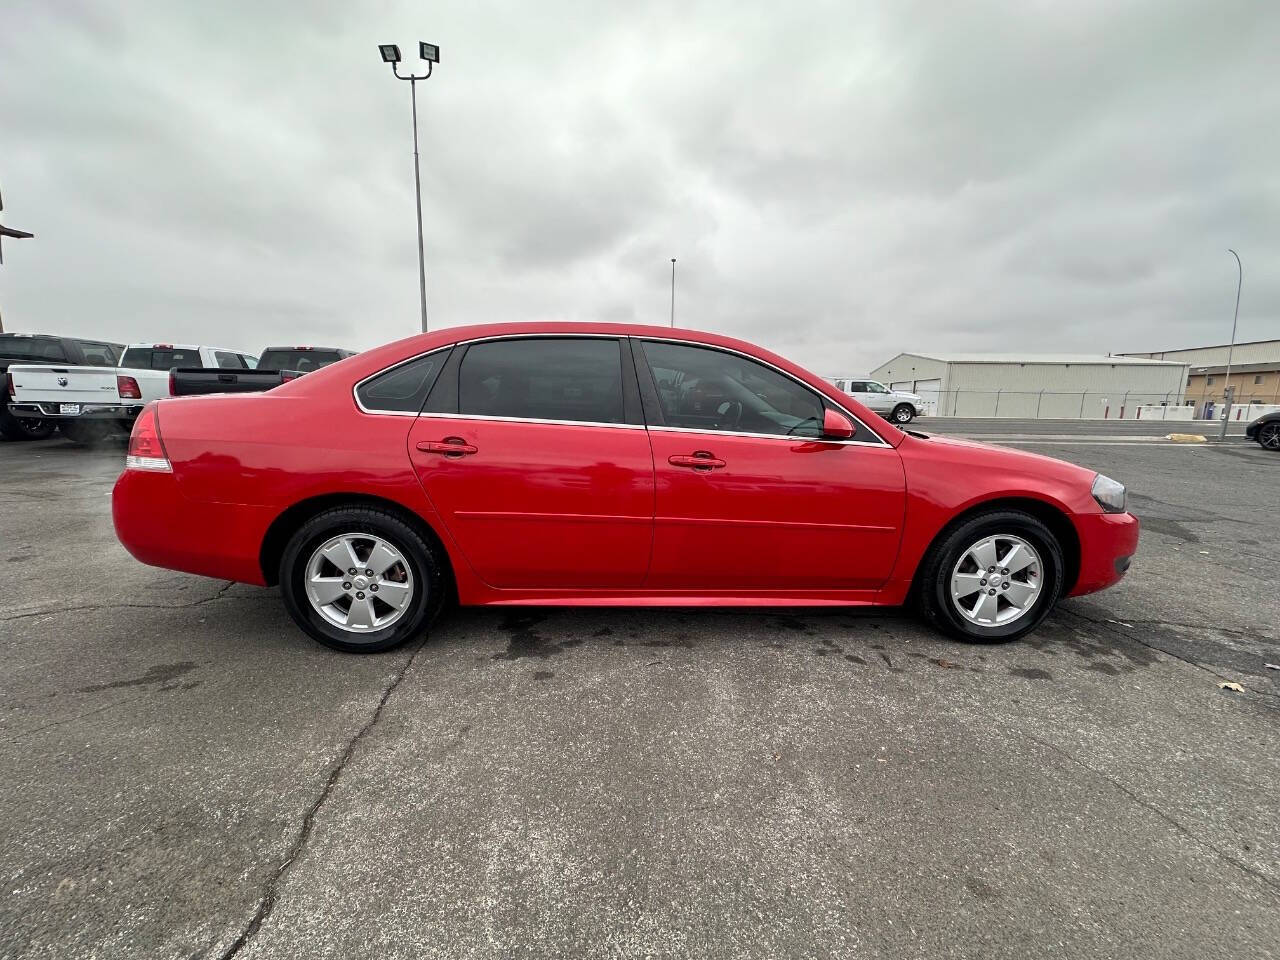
[918,509,1064,643]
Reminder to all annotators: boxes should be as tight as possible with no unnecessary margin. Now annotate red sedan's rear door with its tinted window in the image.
[408,337,654,590]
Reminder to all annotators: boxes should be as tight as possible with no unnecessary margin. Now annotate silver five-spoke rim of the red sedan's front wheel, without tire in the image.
[951,534,1044,627]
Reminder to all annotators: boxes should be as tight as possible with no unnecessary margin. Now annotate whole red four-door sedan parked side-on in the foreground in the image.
[113,324,1138,652]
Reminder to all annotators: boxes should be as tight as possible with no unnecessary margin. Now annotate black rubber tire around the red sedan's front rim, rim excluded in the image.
[916,509,1064,644]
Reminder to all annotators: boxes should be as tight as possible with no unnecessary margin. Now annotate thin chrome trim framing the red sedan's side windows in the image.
[351,332,893,449]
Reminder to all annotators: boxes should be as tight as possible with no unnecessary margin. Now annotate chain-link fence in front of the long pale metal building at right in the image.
[922,389,1280,420]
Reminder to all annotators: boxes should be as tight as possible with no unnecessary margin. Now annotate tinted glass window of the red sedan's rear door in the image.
[458,337,625,424]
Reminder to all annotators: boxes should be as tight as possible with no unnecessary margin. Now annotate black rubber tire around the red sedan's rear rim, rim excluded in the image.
[280,507,448,653]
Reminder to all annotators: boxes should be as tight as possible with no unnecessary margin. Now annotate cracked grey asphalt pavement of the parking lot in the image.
[0,435,1280,960]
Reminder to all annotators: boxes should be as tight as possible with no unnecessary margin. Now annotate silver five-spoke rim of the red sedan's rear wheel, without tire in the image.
[305,532,415,634]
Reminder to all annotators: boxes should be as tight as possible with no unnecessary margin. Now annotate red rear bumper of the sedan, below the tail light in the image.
[111,470,274,585]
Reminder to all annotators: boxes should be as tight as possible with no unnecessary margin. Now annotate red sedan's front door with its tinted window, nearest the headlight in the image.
[635,339,906,591]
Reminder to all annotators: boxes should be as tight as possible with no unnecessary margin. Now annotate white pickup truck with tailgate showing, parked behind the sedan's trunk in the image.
[9,343,257,443]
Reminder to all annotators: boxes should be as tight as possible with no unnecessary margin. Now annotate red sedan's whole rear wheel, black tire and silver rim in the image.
[280,507,447,653]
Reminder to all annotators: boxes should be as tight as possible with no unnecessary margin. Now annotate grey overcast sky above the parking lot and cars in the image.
[0,0,1280,374]
